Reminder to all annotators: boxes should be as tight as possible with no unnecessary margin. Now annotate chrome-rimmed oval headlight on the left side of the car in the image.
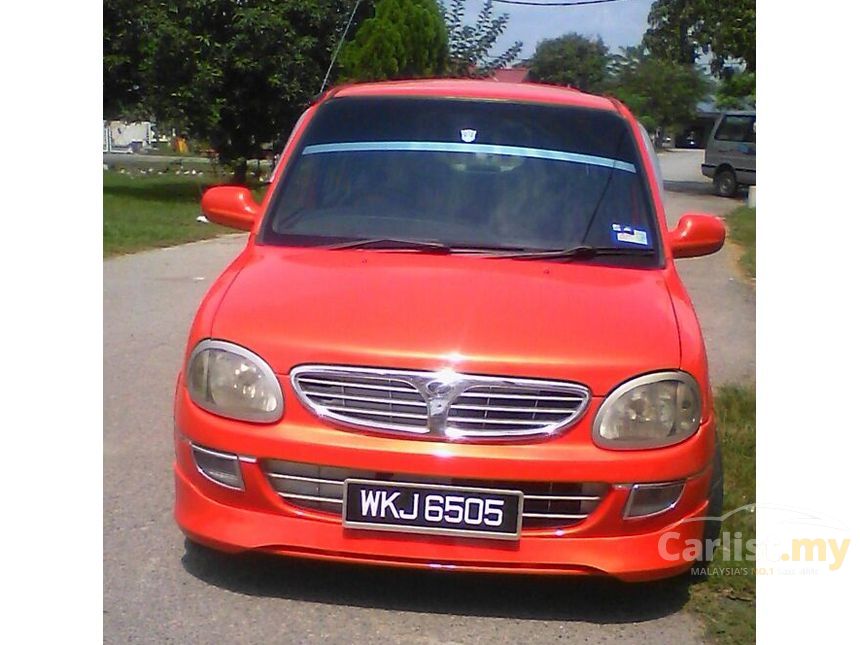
[185,340,284,423]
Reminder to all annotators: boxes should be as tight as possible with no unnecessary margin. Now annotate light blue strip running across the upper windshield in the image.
[302,141,636,175]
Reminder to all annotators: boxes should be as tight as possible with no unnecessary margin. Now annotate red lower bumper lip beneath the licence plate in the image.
[175,460,707,581]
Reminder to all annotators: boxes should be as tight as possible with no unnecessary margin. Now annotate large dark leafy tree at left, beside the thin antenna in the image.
[130,0,353,182]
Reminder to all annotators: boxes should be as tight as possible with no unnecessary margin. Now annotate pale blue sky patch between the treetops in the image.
[450,0,653,58]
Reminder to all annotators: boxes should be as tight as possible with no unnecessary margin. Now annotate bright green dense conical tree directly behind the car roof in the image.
[342,0,448,80]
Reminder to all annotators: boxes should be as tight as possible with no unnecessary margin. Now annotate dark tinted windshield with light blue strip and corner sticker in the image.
[261,98,657,263]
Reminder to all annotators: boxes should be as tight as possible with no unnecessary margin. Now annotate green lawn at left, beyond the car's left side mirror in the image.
[103,170,263,257]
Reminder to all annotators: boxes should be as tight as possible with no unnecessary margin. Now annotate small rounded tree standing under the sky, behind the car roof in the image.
[529,33,609,92]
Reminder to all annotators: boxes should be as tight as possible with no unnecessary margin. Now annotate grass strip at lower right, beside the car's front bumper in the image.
[689,384,755,644]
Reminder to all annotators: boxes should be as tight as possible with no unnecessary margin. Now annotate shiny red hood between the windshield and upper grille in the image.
[211,247,680,396]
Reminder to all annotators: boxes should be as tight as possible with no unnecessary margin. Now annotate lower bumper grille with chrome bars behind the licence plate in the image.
[261,459,609,529]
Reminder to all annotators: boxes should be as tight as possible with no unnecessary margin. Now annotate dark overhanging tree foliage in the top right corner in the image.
[642,0,755,75]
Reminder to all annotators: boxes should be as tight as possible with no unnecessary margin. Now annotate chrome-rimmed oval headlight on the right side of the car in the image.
[592,372,702,450]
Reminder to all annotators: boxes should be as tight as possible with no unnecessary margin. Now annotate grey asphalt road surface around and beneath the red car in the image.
[104,152,755,645]
